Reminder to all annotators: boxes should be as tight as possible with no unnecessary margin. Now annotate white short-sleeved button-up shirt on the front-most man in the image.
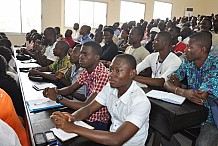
[95,81,151,146]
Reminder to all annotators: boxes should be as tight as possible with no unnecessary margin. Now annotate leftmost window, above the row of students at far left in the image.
[0,0,41,33]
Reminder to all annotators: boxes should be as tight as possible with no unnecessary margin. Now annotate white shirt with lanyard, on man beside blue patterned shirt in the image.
[136,52,182,80]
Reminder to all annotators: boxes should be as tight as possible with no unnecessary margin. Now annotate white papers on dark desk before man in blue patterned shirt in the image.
[146,90,185,105]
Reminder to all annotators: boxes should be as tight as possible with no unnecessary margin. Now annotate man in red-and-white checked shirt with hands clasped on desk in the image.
[43,41,109,130]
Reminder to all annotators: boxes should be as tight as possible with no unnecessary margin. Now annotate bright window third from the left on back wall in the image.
[120,1,145,23]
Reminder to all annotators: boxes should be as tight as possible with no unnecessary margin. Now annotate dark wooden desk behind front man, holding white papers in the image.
[143,88,208,146]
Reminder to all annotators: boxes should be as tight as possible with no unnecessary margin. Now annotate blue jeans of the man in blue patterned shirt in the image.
[195,124,218,146]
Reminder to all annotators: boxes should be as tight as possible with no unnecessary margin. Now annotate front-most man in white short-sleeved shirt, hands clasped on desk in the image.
[51,54,151,146]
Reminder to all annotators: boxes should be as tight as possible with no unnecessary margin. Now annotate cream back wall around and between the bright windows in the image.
[7,0,218,44]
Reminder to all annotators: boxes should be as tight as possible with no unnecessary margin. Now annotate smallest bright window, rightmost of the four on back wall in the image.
[153,1,172,20]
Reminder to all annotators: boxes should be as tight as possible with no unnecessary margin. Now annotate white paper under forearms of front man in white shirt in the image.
[50,121,94,141]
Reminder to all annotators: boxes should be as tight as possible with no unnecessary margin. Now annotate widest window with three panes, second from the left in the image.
[65,0,107,28]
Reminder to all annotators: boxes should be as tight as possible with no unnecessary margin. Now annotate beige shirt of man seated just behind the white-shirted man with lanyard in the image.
[125,46,150,64]
